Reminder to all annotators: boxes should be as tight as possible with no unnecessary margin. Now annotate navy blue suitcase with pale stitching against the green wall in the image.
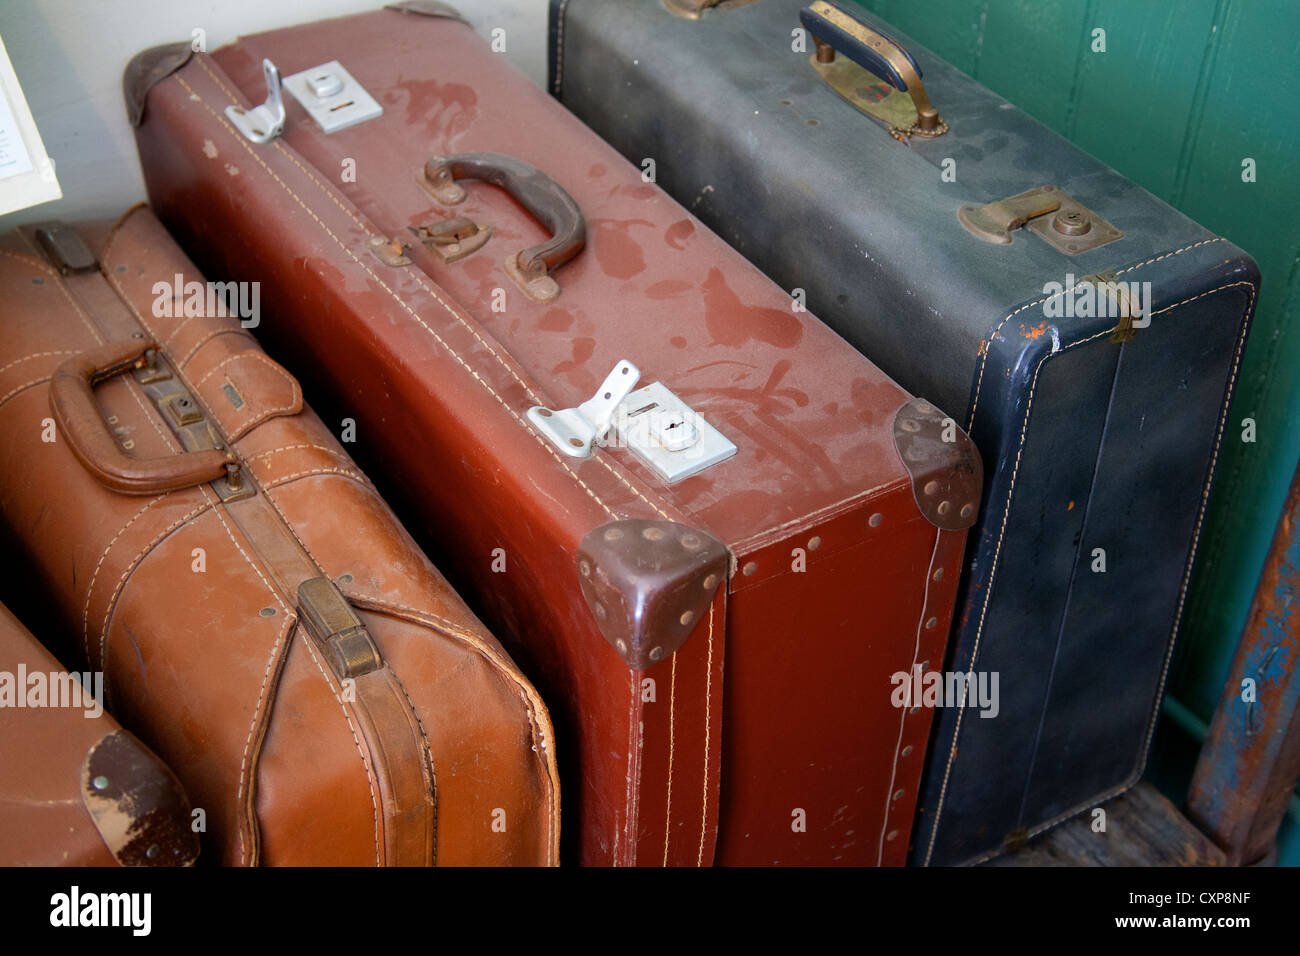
[550,0,1258,864]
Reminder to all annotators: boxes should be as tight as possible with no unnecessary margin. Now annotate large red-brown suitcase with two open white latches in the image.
[126,3,980,865]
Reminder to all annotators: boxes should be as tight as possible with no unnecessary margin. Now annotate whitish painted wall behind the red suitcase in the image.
[0,0,547,232]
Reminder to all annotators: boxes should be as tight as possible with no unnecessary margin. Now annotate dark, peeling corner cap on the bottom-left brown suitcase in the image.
[81,730,199,866]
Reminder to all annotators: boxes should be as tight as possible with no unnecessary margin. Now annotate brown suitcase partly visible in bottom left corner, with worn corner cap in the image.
[0,605,199,866]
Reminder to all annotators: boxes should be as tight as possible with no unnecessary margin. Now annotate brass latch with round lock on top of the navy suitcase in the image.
[957,186,1125,255]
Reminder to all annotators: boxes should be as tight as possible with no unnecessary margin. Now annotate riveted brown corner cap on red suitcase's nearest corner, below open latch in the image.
[577,519,728,670]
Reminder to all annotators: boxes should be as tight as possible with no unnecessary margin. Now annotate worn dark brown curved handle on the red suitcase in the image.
[424,152,586,302]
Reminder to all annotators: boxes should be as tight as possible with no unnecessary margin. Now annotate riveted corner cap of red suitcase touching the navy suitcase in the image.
[893,398,984,531]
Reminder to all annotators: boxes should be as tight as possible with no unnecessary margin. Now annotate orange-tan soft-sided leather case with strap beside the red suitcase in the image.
[0,207,559,865]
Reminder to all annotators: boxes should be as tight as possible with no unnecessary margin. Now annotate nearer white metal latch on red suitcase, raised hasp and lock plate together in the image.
[528,359,736,484]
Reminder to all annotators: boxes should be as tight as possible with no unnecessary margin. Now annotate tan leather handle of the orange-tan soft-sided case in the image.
[49,339,235,494]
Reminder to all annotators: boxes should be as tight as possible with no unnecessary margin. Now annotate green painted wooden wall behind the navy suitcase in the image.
[862,0,1300,862]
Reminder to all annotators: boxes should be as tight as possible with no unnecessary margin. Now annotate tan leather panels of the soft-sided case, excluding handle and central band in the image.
[0,209,559,865]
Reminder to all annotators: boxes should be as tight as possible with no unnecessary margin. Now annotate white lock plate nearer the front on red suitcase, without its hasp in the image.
[605,382,736,484]
